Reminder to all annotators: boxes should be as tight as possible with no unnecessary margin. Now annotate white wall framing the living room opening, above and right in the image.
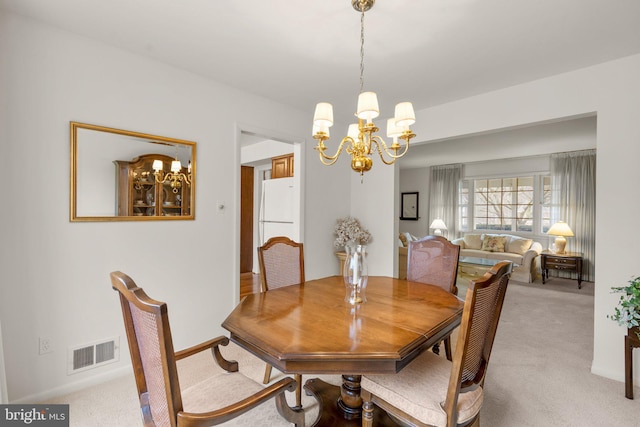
[404,55,640,380]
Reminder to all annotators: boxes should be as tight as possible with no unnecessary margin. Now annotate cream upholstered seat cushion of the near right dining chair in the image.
[362,352,484,426]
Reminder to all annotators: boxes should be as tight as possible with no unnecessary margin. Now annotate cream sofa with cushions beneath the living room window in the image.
[451,233,542,283]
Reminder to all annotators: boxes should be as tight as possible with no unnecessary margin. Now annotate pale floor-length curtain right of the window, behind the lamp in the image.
[551,150,596,281]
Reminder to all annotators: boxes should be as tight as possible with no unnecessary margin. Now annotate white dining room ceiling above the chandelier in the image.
[0,0,640,150]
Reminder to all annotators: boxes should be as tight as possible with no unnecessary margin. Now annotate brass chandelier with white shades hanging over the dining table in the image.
[313,0,416,180]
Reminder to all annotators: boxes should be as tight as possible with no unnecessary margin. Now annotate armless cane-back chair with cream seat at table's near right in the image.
[361,262,511,427]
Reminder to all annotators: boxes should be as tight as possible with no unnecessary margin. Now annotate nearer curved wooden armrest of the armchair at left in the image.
[178,377,304,427]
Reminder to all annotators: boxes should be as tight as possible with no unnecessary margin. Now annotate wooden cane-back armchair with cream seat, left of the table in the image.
[111,271,305,427]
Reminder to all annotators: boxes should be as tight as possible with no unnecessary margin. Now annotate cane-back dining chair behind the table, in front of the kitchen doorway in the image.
[258,236,304,409]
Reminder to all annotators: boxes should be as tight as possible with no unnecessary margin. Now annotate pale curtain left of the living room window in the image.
[427,164,462,240]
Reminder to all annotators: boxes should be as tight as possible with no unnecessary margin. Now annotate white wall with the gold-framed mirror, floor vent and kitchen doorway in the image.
[0,11,350,402]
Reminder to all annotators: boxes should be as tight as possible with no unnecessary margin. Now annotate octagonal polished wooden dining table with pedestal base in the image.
[222,276,464,426]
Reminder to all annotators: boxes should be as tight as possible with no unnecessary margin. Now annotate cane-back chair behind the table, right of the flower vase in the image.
[407,236,460,360]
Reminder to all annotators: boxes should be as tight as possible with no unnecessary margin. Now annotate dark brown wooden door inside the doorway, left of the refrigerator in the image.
[240,166,256,273]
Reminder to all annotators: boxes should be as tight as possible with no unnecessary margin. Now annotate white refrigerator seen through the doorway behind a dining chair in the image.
[258,178,298,246]
